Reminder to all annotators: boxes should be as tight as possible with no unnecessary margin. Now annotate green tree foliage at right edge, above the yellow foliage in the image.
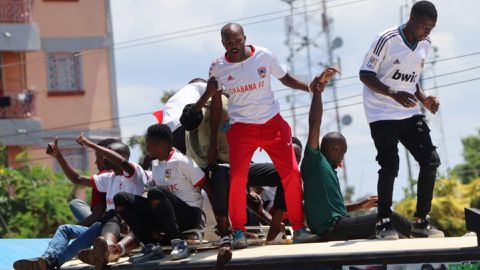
[452,131,480,183]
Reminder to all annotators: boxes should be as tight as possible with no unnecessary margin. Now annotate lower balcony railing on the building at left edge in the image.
[0,90,36,118]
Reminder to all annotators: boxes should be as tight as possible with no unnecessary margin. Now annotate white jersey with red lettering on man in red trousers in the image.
[209,45,287,124]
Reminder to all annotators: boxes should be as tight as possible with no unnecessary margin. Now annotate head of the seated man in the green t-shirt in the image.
[320,132,347,168]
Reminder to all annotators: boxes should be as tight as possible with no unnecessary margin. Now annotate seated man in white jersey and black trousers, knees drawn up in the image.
[114,124,210,260]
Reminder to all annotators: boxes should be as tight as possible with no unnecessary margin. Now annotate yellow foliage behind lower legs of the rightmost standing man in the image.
[395,178,480,236]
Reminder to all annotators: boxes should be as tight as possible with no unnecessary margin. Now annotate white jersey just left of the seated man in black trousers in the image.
[90,162,147,211]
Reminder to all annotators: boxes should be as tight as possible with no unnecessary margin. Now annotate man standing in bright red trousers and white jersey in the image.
[202,23,318,248]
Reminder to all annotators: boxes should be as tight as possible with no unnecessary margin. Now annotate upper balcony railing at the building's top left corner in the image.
[0,0,33,23]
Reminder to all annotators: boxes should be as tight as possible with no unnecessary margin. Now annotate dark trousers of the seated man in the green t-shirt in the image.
[322,212,412,241]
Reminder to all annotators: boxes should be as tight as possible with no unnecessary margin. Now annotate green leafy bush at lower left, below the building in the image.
[0,163,74,238]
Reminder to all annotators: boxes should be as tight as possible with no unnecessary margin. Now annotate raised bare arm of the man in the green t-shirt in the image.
[307,68,339,149]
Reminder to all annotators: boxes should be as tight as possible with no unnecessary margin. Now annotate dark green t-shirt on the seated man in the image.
[300,144,347,236]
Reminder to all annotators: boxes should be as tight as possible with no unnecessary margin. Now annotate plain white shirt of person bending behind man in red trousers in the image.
[162,82,207,132]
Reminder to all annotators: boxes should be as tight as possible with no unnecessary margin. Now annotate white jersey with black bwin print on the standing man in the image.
[360,26,431,123]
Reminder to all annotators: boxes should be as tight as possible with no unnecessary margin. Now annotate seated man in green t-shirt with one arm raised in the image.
[300,68,411,241]
